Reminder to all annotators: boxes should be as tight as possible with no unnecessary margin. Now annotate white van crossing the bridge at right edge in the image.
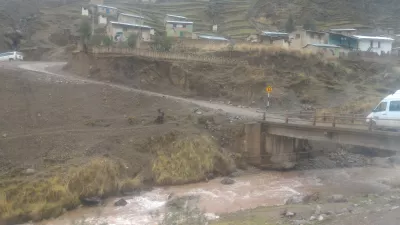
[367,90,400,129]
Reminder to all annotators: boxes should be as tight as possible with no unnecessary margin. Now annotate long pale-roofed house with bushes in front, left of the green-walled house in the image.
[107,21,154,42]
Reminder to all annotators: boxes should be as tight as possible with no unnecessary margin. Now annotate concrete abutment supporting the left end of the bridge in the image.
[244,123,306,169]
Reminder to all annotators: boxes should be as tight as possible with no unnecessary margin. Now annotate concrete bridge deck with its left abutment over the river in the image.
[244,121,400,169]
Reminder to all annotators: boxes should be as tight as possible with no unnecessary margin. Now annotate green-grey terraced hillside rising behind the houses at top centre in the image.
[104,0,256,38]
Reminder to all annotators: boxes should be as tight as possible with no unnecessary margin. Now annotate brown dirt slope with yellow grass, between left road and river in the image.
[0,69,244,224]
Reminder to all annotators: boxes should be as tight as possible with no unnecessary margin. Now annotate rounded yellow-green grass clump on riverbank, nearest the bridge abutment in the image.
[153,135,234,185]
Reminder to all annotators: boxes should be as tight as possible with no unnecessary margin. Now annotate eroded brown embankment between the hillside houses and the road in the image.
[66,50,400,110]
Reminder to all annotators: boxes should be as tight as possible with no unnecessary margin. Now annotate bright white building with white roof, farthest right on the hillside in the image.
[353,35,394,55]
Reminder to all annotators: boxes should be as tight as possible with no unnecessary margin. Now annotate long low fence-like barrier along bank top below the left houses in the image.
[89,47,248,65]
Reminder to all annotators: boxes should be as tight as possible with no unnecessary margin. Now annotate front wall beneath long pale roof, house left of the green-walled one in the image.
[107,24,151,41]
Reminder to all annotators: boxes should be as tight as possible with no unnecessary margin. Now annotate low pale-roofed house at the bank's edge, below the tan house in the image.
[303,44,349,59]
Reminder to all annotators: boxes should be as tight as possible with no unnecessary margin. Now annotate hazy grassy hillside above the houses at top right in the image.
[253,0,400,29]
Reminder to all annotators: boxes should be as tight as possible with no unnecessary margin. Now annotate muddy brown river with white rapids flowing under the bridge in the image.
[32,167,400,225]
